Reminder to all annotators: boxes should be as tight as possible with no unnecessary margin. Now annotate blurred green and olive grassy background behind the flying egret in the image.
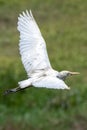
[0,0,87,130]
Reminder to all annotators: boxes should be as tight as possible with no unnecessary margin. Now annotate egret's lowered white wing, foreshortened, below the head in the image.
[32,76,70,89]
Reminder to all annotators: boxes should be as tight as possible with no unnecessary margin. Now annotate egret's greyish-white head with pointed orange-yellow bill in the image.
[60,70,80,80]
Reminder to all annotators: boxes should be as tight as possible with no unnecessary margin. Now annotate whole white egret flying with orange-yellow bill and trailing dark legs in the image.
[5,10,79,94]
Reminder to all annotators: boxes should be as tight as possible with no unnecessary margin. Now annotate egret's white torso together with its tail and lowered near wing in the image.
[19,69,69,89]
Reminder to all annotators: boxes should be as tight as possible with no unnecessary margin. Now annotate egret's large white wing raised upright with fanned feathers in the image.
[18,11,51,76]
